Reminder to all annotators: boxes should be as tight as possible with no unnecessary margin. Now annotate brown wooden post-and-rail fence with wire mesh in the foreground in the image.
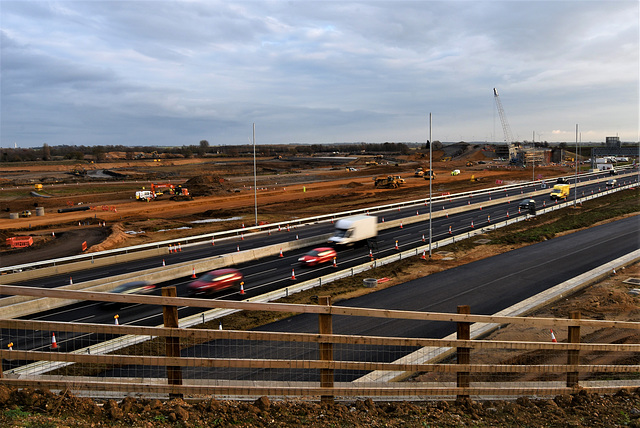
[0,285,640,402]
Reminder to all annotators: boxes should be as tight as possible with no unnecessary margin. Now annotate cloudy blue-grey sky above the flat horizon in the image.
[0,0,640,147]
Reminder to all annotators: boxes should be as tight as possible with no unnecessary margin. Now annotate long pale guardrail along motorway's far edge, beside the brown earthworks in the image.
[0,167,632,274]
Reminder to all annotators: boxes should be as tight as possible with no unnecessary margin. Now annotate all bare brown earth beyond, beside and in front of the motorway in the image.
[0,151,640,427]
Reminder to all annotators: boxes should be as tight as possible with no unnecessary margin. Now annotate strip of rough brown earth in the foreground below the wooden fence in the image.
[0,386,640,428]
